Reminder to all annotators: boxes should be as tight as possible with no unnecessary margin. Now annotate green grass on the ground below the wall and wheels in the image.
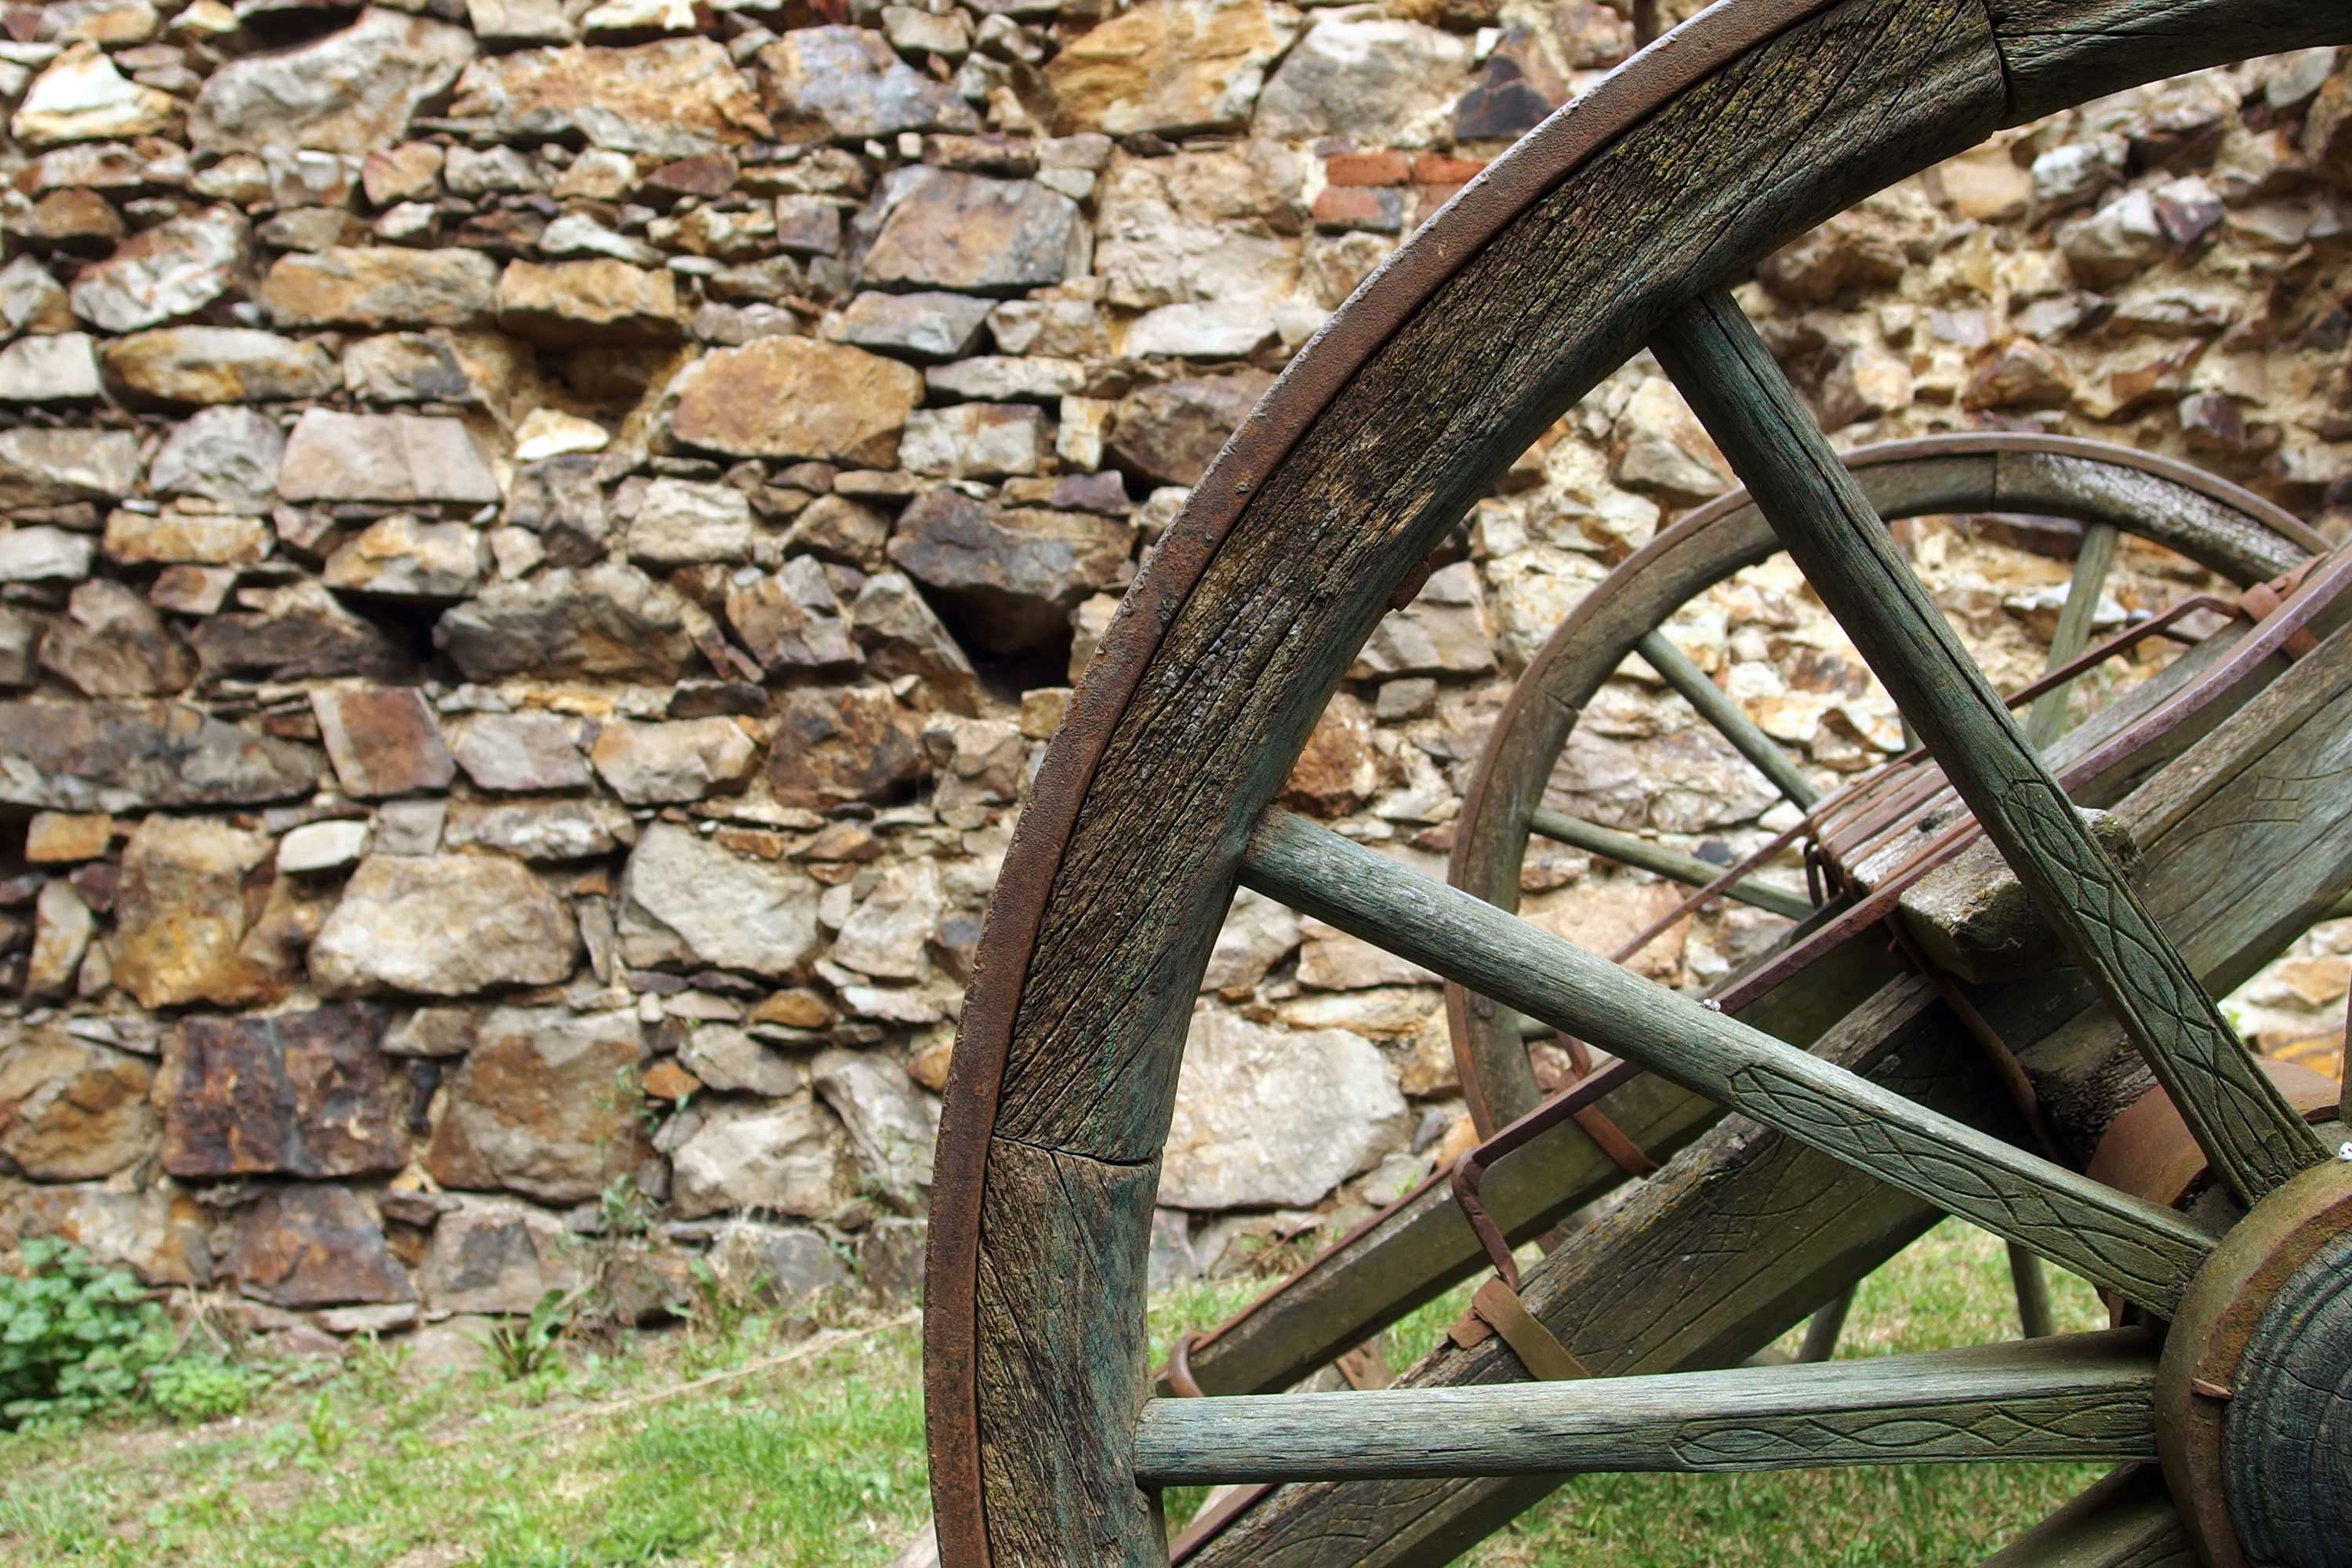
[0,1225,2103,1568]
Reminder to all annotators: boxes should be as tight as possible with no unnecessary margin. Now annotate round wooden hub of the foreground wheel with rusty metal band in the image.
[2157,1159,2352,1568]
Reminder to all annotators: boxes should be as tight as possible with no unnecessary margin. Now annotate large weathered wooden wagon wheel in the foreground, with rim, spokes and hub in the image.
[927,0,2352,1568]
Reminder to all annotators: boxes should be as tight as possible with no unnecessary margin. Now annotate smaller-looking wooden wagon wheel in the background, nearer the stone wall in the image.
[1446,433,2326,1359]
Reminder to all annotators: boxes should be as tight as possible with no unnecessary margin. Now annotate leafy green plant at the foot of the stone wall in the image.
[0,1236,174,1427]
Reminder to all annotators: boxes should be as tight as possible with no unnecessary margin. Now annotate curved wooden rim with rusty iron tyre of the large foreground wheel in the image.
[927,0,2345,1568]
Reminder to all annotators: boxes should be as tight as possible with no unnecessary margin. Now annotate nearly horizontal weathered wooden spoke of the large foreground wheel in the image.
[1136,1328,2157,1486]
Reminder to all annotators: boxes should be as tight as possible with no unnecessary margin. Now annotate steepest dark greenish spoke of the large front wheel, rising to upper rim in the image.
[1653,292,2324,1203]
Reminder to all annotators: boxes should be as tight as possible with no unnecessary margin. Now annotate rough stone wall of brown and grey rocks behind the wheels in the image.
[0,0,2352,1330]
